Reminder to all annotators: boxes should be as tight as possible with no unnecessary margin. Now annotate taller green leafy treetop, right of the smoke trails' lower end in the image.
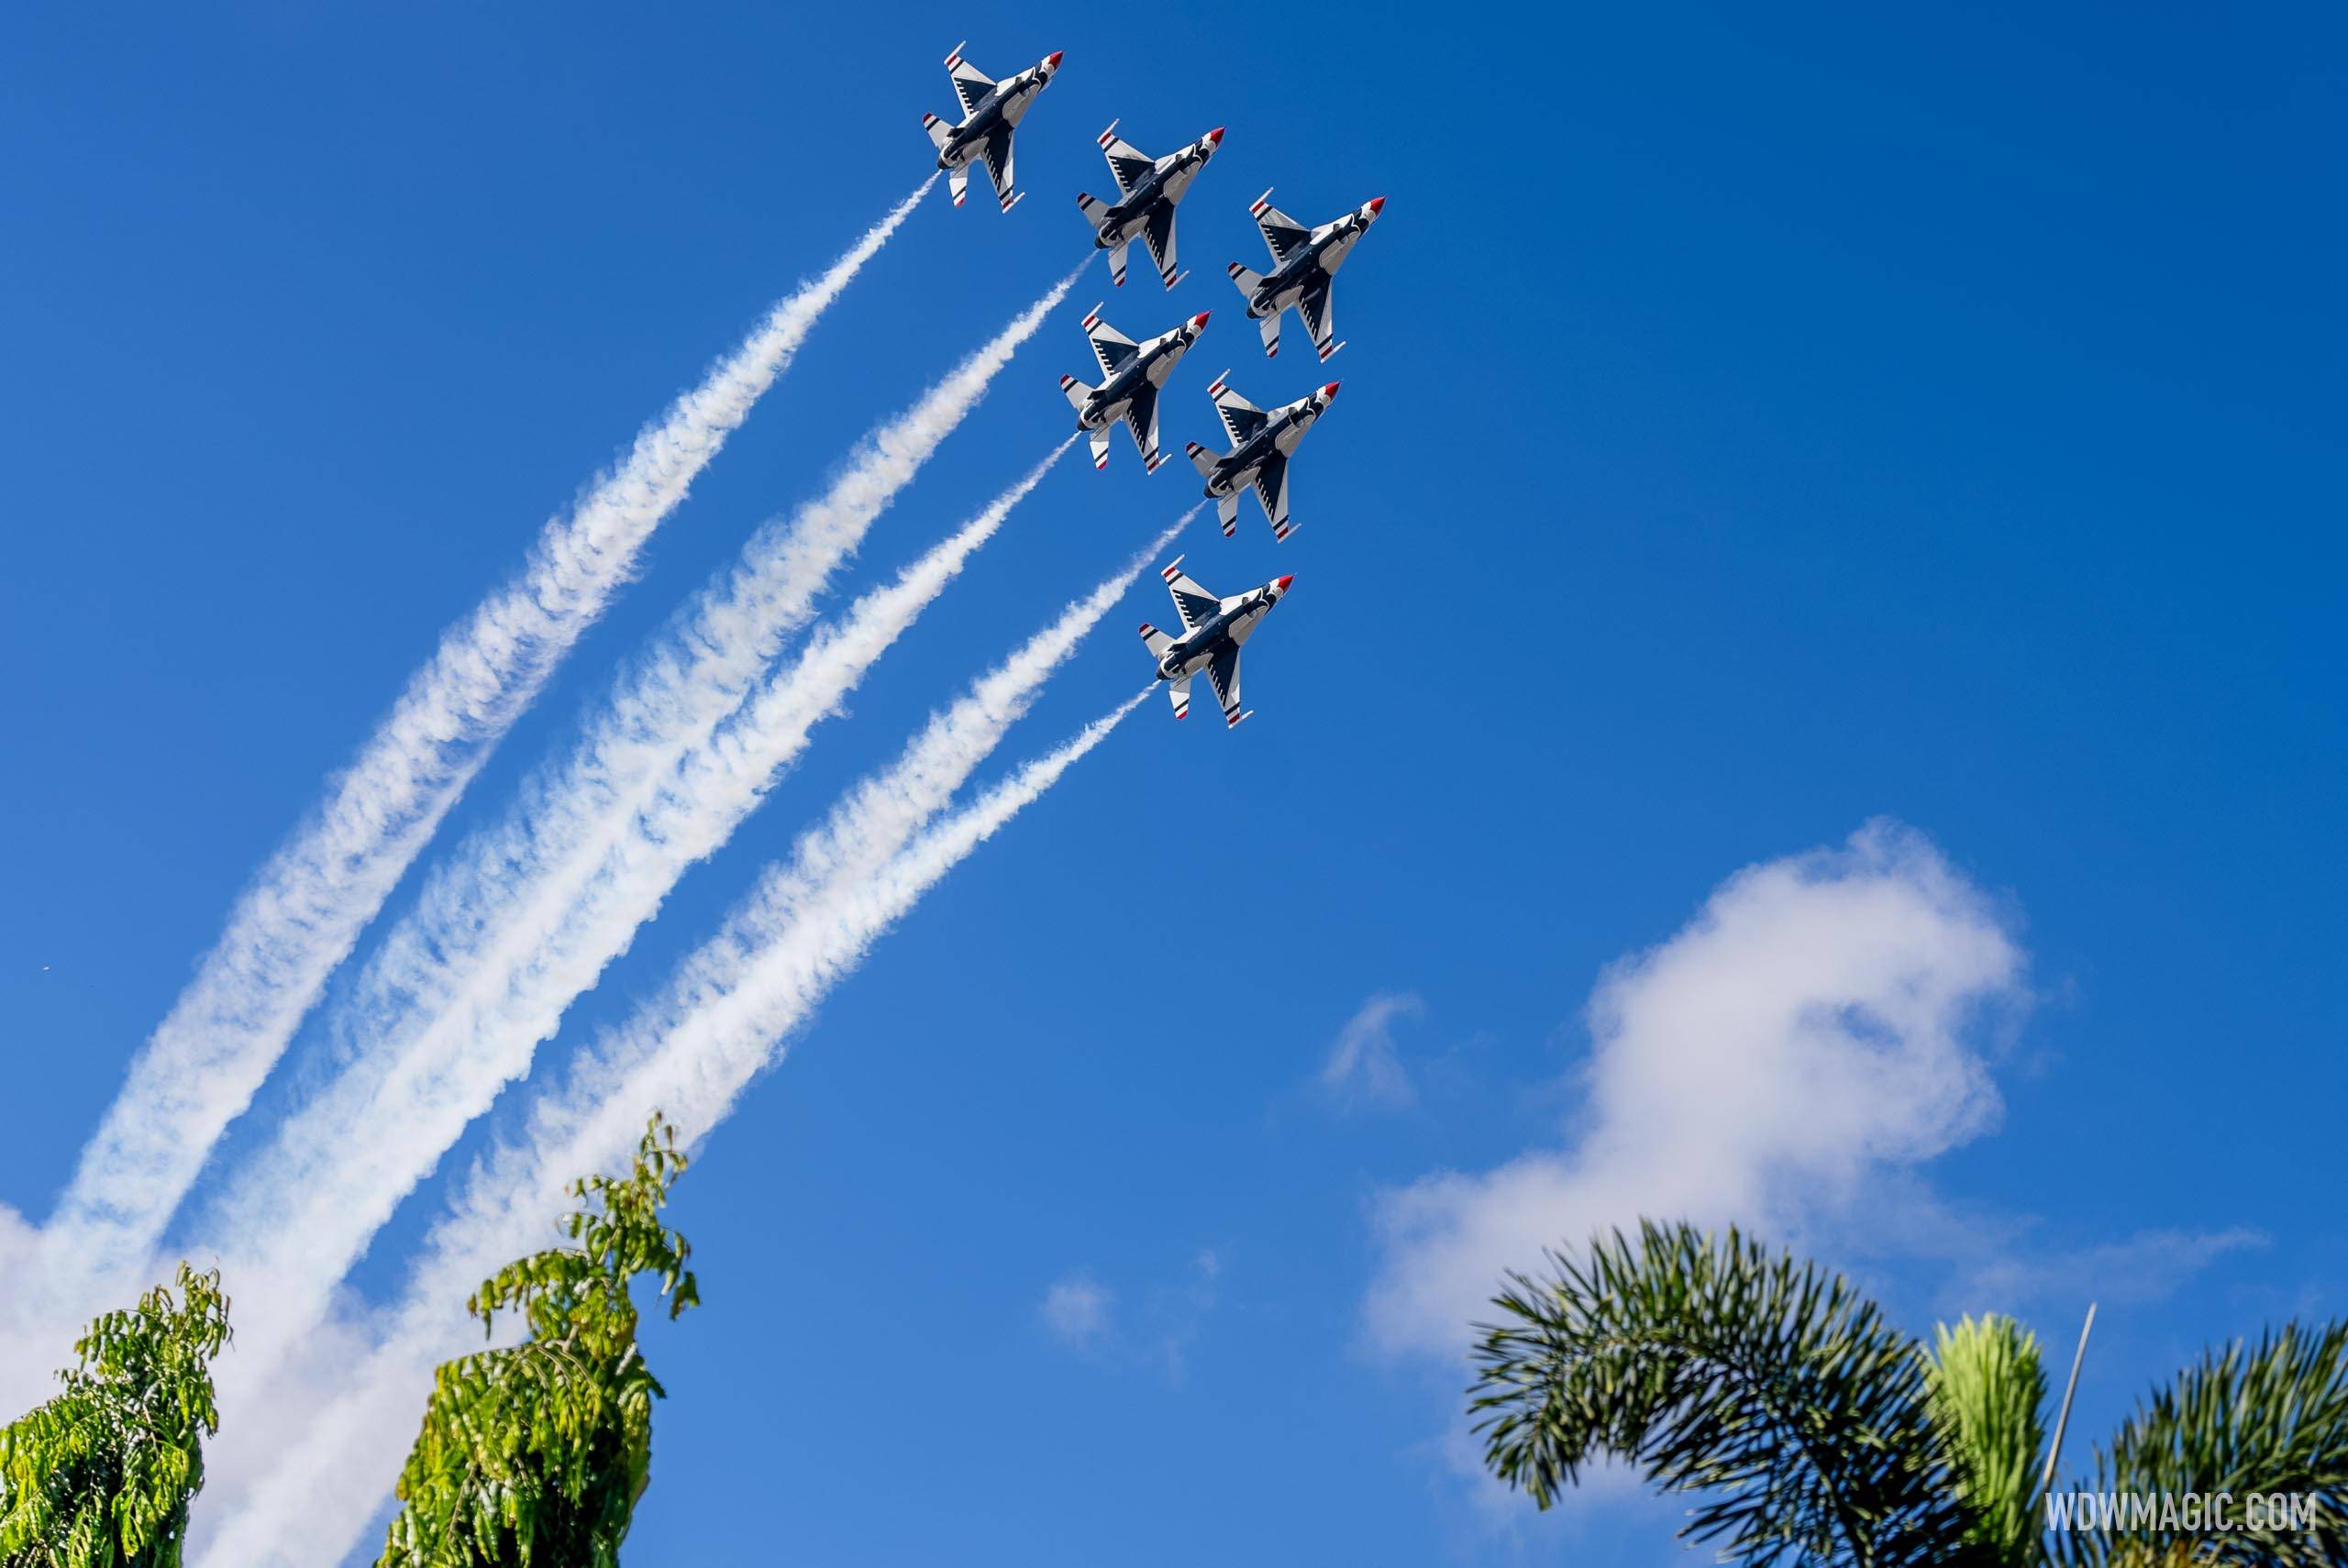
[378,1115,700,1568]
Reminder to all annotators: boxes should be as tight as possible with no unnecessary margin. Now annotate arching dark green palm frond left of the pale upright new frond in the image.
[1470,1223,1982,1568]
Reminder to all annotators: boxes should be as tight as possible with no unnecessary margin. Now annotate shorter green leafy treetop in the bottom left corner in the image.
[0,1263,227,1568]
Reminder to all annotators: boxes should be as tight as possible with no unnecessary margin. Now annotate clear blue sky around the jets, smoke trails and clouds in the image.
[0,5,2348,1563]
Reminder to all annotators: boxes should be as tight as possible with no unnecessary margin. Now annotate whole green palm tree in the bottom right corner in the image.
[1470,1223,2348,1568]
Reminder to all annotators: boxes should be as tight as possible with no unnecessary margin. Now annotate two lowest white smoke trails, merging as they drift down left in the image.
[202,593,1171,1568]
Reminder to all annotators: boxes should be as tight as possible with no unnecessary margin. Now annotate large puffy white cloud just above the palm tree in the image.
[1367,822,2026,1357]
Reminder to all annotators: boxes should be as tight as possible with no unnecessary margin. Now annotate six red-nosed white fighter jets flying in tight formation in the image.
[921,45,1385,728]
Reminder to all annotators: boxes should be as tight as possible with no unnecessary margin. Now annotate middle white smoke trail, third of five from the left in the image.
[202,436,1075,1370]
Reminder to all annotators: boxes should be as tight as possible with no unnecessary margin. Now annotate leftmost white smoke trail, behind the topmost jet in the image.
[25,176,936,1303]
